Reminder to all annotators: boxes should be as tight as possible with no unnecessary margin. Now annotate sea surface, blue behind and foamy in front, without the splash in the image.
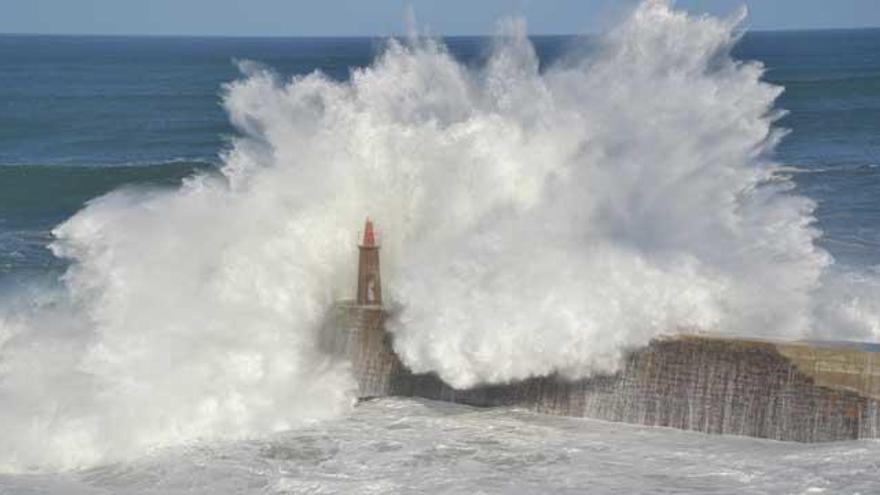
[0,30,880,494]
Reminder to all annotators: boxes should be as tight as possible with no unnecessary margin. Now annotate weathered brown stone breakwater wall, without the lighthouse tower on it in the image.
[323,302,880,442]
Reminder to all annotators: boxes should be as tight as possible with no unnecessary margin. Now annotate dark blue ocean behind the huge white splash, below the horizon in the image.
[0,30,880,280]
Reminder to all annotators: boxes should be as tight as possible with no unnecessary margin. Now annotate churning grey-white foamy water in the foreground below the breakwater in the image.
[0,399,880,495]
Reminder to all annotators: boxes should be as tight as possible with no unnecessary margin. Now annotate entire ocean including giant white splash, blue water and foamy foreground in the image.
[0,2,880,494]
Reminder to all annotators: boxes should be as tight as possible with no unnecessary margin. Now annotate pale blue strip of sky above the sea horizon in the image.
[0,0,880,36]
